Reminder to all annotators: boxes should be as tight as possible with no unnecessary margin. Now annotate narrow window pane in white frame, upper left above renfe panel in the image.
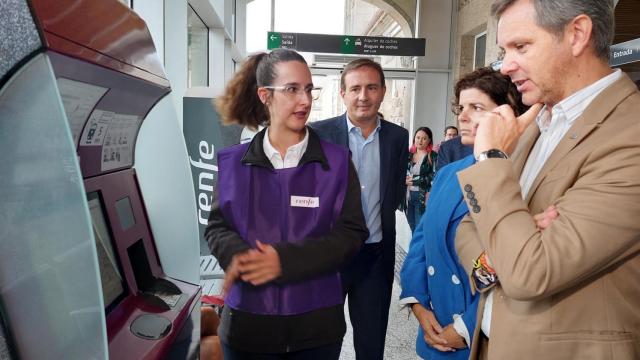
[187,5,209,87]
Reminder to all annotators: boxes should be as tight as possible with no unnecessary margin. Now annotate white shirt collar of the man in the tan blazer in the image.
[536,69,622,132]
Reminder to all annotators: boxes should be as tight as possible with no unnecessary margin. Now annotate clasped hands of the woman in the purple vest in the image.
[238,240,282,285]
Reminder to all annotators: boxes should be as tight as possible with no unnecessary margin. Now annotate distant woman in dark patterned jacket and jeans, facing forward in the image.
[404,127,438,233]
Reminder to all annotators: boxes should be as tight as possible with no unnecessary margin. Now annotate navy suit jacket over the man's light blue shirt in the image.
[307,113,409,281]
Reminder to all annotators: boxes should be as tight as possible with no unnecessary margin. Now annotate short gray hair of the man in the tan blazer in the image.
[491,0,615,61]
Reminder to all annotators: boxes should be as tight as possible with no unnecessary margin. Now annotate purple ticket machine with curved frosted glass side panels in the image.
[0,0,200,359]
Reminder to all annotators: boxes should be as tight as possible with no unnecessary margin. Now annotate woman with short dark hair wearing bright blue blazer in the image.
[400,68,526,360]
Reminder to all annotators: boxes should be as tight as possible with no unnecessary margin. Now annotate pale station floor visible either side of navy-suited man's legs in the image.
[340,211,419,360]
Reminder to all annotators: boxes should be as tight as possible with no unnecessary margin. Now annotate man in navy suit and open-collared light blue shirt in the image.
[309,59,409,360]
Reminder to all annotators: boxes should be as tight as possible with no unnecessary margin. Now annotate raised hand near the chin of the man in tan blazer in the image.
[471,104,542,157]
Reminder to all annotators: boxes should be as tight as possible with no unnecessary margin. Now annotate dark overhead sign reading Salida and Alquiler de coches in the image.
[267,32,426,56]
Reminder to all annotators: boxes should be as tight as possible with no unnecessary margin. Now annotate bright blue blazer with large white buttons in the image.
[400,155,479,360]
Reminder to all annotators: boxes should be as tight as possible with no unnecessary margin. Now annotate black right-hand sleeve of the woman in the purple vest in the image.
[274,161,369,283]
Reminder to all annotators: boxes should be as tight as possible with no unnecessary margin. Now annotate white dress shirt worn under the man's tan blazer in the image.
[480,69,622,337]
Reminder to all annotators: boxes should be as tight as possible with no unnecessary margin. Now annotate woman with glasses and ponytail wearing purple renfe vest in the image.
[205,49,368,360]
